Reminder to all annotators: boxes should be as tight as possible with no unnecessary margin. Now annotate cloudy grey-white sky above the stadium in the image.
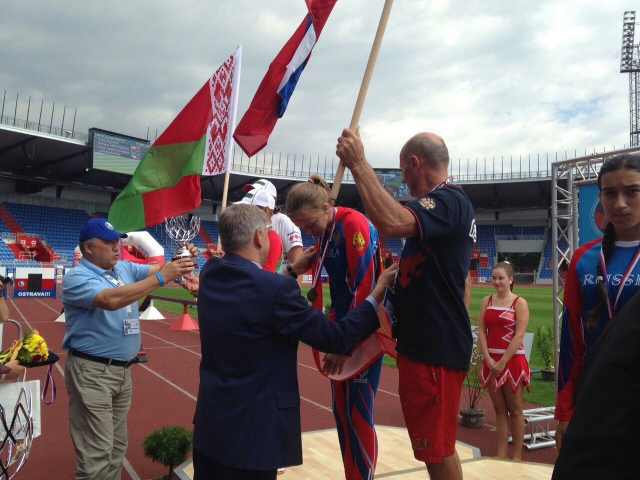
[0,0,640,171]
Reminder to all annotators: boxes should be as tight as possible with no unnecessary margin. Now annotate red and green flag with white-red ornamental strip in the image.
[109,46,242,232]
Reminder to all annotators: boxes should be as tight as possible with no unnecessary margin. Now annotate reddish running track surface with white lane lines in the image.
[4,298,556,480]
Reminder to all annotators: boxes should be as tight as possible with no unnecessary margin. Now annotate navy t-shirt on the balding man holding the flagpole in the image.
[395,183,476,370]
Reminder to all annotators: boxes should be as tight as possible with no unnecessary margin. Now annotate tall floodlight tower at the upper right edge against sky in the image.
[620,10,640,147]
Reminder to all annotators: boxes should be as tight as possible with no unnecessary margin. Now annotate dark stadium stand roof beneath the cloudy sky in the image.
[0,122,551,214]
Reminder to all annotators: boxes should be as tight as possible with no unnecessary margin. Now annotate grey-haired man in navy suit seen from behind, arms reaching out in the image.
[193,204,395,480]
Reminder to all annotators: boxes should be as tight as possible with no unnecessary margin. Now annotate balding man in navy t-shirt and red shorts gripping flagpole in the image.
[336,129,476,480]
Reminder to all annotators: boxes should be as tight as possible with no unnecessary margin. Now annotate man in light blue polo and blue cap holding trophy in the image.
[62,218,197,480]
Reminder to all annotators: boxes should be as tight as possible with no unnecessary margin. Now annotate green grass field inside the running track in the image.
[148,285,555,406]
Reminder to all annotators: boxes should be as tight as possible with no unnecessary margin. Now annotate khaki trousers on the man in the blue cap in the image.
[64,355,132,480]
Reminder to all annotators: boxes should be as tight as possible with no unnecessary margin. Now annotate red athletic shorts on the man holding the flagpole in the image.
[398,353,467,463]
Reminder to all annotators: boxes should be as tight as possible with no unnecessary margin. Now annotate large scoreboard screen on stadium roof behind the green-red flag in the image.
[89,128,151,175]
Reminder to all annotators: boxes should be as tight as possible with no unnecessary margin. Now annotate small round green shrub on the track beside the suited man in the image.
[142,425,193,480]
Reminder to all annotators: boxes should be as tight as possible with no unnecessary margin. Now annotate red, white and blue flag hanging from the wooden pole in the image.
[233,0,337,157]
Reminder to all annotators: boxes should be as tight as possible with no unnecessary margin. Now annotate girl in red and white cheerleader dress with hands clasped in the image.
[478,262,531,460]
